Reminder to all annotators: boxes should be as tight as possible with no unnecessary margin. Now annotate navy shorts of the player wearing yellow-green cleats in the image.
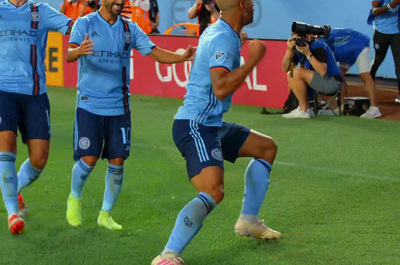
[73,108,131,160]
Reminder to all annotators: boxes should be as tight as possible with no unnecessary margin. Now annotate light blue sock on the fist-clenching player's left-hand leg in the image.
[162,192,217,254]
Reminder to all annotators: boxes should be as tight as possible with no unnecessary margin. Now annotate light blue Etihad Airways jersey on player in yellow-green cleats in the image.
[70,12,156,116]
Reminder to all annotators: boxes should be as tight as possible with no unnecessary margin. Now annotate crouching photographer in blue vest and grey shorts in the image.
[282,23,343,119]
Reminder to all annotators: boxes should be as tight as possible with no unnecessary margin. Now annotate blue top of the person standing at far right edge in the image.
[371,0,400,34]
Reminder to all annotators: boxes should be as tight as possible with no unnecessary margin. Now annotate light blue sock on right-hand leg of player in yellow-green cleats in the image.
[101,164,124,212]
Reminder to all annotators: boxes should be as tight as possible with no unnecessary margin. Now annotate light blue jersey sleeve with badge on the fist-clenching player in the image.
[208,37,239,72]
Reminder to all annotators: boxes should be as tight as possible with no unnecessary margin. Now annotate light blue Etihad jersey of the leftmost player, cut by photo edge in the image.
[0,1,72,95]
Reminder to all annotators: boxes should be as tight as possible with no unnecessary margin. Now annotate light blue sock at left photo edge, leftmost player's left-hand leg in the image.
[0,152,18,216]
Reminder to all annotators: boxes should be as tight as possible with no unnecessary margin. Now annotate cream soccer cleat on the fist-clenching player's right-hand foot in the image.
[235,218,281,239]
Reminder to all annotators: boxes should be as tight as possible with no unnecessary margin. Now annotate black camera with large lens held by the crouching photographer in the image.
[292,21,331,47]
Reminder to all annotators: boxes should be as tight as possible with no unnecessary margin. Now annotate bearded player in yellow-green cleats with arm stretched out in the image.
[66,0,195,229]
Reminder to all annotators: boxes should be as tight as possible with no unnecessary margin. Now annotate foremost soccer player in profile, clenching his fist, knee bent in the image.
[151,0,281,265]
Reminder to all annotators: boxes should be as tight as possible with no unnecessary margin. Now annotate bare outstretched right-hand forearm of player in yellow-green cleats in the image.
[148,46,196,63]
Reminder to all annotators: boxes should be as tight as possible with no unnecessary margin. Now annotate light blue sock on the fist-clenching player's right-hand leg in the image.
[240,158,272,223]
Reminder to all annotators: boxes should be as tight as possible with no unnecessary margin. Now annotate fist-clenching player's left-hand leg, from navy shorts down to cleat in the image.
[152,120,224,265]
